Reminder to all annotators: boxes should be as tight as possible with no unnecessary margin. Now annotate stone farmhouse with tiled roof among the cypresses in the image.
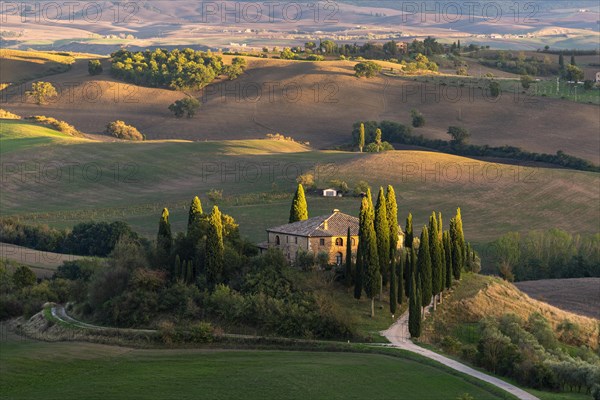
[259,209,404,265]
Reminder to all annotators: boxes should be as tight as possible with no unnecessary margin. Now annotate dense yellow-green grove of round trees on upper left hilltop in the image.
[111,49,245,90]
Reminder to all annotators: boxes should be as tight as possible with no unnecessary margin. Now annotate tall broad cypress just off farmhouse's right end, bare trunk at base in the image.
[359,192,380,317]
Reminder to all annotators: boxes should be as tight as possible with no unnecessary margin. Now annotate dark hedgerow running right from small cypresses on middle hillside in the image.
[352,121,600,172]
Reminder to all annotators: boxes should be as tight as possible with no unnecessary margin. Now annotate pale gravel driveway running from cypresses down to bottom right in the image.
[381,311,539,400]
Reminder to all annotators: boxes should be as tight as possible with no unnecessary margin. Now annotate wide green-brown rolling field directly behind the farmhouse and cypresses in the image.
[0,121,600,242]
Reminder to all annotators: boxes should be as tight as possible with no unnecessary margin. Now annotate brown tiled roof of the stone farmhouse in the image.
[267,210,358,237]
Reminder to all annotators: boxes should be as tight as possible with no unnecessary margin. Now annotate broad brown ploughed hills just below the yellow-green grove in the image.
[3,52,600,163]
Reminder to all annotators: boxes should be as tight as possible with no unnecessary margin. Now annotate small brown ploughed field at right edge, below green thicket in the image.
[515,278,600,319]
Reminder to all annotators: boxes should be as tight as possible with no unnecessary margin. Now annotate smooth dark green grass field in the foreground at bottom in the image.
[0,338,516,400]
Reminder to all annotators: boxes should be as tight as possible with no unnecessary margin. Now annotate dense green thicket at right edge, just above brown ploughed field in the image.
[483,229,600,281]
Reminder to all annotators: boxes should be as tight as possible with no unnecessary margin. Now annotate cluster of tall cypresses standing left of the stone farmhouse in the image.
[156,196,225,288]
